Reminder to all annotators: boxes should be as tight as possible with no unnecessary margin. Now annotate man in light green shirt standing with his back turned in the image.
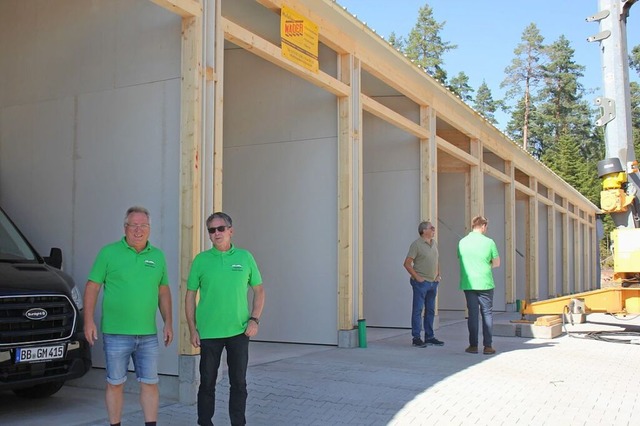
[458,216,500,355]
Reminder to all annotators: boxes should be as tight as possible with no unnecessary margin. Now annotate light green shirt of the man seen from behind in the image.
[458,231,498,290]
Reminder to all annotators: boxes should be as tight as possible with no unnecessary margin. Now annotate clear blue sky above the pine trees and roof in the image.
[336,0,640,128]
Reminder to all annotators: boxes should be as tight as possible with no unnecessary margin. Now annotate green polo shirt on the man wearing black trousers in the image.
[187,245,262,339]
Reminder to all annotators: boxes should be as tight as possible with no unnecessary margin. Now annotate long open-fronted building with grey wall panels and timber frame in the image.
[0,0,600,403]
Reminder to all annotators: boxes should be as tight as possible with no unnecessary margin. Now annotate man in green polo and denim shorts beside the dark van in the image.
[84,206,173,426]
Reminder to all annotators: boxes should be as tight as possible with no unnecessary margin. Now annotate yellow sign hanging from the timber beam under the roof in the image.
[280,6,318,73]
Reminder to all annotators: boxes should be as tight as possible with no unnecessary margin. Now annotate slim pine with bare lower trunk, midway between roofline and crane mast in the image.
[500,23,545,151]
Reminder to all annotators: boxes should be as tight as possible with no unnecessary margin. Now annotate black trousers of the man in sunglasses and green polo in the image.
[198,334,249,426]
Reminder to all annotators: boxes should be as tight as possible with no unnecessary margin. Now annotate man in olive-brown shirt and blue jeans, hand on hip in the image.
[404,221,444,348]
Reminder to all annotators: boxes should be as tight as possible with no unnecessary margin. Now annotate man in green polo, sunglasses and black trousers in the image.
[185,212,264,425]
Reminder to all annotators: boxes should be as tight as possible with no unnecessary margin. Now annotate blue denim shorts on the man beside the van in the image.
[103,334,158,386]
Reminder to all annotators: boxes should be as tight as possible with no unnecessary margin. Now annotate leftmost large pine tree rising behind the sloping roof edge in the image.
[405,4,458,84]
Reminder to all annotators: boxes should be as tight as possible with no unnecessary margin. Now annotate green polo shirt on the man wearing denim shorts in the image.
[89,237,169,335]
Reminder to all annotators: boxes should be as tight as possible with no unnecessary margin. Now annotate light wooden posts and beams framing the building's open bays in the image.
[150,0,599,354]
